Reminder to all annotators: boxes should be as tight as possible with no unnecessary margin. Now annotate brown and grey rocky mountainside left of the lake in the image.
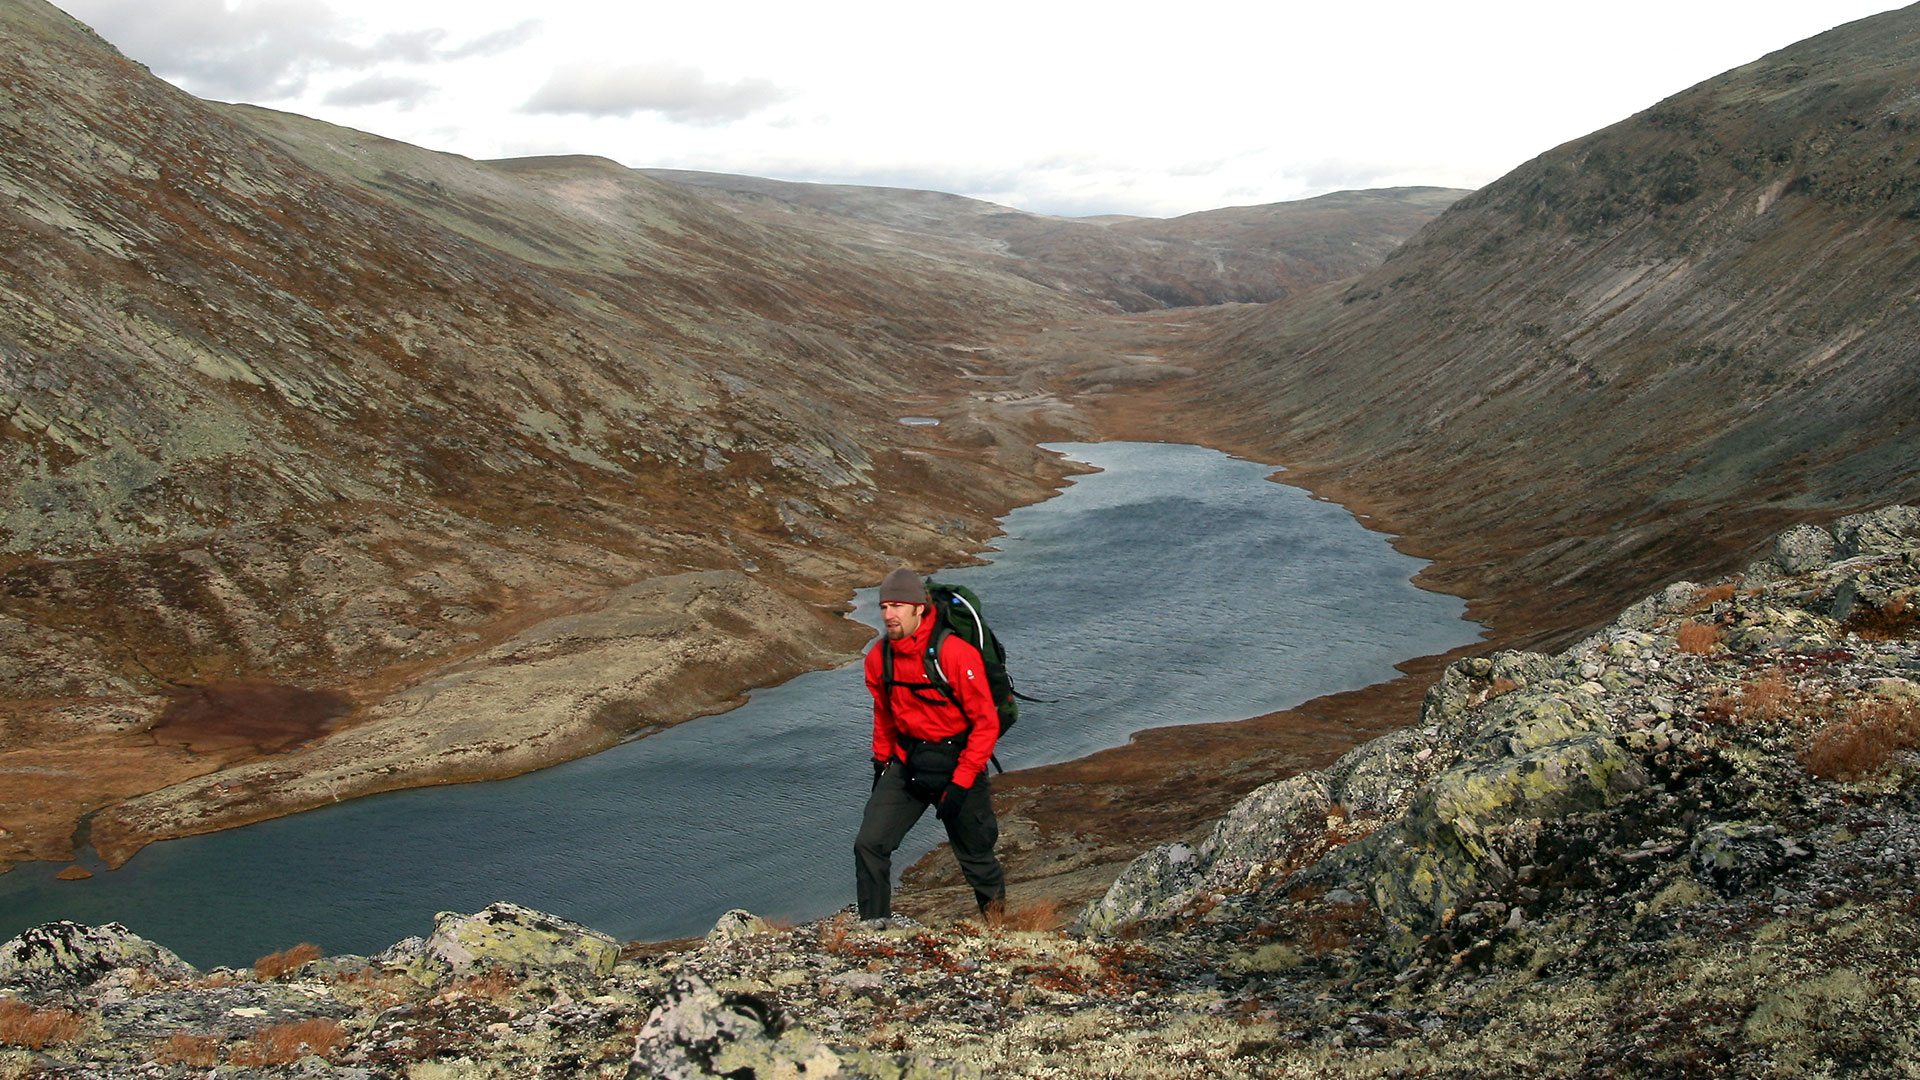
[0,0,1438,865]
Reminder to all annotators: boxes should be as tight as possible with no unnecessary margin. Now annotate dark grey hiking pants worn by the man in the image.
[852,761,1006,919]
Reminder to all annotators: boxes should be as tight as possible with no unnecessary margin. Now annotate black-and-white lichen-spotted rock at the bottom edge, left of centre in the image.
[628,974,841,1080]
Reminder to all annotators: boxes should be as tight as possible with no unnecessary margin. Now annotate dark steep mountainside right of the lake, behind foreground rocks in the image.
[1121,8,1920,642]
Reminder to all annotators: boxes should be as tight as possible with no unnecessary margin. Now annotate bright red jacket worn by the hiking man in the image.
[866,611,1000,788]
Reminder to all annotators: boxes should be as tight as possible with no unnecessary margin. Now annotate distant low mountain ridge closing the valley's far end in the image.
[645,169,1467,311]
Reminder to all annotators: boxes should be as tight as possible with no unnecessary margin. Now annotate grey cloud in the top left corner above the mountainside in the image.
[65,0,540,102]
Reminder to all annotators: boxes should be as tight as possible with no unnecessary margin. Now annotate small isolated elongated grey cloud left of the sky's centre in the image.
[520,63,789,127]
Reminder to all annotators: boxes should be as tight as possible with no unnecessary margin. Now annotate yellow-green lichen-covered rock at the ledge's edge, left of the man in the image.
[420,903,620,976]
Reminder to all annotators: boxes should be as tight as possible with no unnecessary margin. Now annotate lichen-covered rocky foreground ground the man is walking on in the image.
[0,507,1920,1078]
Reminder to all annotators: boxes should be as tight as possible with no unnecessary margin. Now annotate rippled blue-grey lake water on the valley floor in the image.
[0,442,1480,967]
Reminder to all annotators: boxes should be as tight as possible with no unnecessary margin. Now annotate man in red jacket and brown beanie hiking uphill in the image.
[852,567,1006,924]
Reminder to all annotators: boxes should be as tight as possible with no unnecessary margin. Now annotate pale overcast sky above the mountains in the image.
[56,0,1897,217]
